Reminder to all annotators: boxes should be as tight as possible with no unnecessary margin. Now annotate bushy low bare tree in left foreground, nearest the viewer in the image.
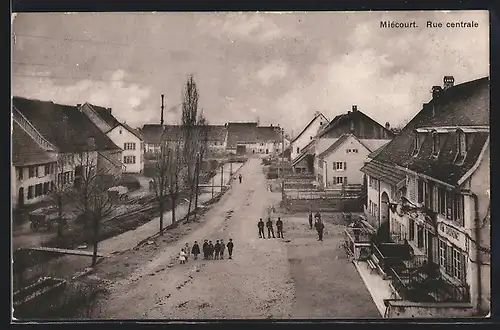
[73,151,114,266]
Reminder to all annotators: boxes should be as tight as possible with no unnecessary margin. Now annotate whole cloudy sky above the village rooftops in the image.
[12,11,489,132]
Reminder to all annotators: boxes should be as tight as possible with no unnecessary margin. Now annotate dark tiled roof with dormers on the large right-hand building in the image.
[375,77,490,185]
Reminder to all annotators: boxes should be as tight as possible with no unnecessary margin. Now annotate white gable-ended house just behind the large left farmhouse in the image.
[77,103,144,173]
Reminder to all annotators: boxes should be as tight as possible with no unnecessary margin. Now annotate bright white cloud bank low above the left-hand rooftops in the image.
[13,70,151,125]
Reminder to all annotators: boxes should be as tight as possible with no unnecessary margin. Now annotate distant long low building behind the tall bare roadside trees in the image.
[141,124,227,154]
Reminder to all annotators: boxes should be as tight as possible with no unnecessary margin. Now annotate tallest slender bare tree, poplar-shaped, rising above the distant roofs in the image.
[182,76,199,221]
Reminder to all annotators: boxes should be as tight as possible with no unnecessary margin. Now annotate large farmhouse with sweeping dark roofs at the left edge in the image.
[12,97,122,206]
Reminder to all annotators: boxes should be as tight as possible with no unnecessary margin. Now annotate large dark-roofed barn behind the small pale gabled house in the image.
[292,105,394,178]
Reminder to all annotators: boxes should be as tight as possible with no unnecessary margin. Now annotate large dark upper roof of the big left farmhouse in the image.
[12,97,120,152]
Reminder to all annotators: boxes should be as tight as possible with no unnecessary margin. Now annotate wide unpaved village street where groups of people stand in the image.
[93,158,380,319]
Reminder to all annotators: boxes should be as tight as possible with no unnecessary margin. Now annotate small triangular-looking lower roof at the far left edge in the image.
[12,121,56,166]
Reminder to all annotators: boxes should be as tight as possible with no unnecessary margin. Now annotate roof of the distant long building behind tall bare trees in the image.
[141,124,226,144]
